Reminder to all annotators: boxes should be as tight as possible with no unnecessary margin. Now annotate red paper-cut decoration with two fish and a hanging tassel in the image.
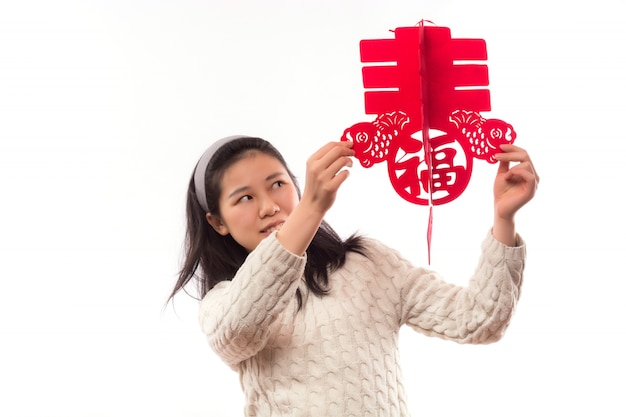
[341,20,516,263]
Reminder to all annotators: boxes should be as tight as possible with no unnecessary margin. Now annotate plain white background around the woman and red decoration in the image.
[0,0,626,417]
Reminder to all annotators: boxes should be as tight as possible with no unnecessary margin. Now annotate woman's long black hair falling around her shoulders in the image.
[168,137,365,308]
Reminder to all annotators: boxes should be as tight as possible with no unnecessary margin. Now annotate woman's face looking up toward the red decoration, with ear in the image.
[207,151,298,252]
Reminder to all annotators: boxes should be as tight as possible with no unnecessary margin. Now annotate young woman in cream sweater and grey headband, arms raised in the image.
[170,136,539,417]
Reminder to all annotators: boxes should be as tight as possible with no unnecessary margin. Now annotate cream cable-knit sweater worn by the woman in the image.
[200,233,525,417]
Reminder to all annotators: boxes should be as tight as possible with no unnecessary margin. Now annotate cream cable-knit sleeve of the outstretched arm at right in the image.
[401,232,526,344]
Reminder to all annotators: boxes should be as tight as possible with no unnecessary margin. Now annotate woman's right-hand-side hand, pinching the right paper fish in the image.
[493,144,539,221]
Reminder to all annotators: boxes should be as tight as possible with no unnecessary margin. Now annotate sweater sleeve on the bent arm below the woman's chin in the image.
[199,233,306,367]
